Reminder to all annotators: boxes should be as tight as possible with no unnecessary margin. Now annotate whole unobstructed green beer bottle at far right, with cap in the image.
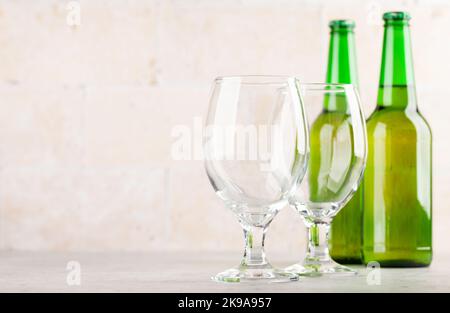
[363,12,432,267]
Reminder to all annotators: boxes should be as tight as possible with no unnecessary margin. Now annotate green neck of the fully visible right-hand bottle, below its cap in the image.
[377,21,417,110]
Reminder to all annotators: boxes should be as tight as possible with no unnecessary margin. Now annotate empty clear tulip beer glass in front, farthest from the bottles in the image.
[203,76,309,282]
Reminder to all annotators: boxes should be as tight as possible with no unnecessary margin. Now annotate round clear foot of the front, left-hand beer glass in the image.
[211,267,298,283]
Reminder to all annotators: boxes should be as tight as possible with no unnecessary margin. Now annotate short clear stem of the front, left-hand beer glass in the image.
[241,225,268,267]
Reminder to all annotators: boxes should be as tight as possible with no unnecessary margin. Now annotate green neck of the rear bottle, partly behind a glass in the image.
[324,29,358,112]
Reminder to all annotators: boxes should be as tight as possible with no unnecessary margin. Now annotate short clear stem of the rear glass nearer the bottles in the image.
[306,223,331,262]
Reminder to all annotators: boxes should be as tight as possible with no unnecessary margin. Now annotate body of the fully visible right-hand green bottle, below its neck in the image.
[363,91,432,267]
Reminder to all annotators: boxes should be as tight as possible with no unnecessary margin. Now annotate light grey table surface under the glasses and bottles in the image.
[0,251,450,293]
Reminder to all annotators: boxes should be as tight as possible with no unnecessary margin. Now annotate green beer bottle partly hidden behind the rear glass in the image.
[323,20,362,264]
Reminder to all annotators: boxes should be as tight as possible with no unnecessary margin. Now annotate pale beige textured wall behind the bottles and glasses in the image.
[0,0,450,255]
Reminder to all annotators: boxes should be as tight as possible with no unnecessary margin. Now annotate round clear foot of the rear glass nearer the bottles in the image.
[285,259,358,277]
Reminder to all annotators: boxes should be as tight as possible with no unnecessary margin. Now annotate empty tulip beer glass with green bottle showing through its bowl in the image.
[287,84,367,276]
